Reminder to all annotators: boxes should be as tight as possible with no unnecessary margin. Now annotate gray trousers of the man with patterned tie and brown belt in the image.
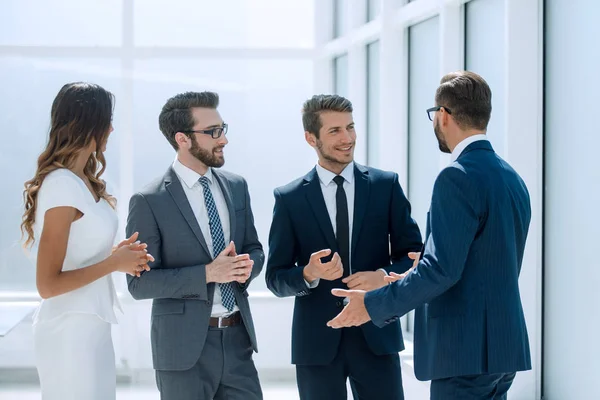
[156,325,263,400]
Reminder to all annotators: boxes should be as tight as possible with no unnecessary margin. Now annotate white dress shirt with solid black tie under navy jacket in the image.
[306,162,354,289]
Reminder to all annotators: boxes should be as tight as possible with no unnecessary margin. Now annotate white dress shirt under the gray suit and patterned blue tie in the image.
[173,159,239,317]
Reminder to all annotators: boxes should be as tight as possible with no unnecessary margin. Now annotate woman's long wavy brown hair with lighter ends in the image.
[21,82,116,247]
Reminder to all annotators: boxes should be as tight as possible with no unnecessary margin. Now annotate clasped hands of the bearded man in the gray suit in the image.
[206,242,254,283]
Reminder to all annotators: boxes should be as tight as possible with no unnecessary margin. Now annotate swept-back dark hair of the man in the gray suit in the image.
[158,92,219,150]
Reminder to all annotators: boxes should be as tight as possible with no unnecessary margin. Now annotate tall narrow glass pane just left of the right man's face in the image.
[406,17,440,331]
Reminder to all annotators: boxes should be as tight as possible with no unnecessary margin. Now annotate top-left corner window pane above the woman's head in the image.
[0,0,122,46]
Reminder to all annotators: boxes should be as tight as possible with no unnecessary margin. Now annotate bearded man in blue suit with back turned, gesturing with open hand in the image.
[329,72,531,400]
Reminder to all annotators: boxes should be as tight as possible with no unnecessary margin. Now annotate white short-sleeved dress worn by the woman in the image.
[31,169,120,400]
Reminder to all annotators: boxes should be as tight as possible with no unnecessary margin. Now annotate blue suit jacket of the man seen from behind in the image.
[365,140,531,380]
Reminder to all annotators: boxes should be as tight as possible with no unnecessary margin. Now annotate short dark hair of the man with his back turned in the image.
[435,71,492,130]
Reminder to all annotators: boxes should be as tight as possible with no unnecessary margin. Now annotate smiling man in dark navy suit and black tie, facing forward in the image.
[266,95,422,400]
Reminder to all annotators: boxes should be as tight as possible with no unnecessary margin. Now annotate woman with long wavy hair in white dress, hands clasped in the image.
[21,83,153,400]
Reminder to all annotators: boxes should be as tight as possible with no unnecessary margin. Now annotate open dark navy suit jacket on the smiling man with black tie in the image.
[266,164,422,365]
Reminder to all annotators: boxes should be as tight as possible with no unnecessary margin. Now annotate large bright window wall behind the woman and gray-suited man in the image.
[0,0,316,292]
